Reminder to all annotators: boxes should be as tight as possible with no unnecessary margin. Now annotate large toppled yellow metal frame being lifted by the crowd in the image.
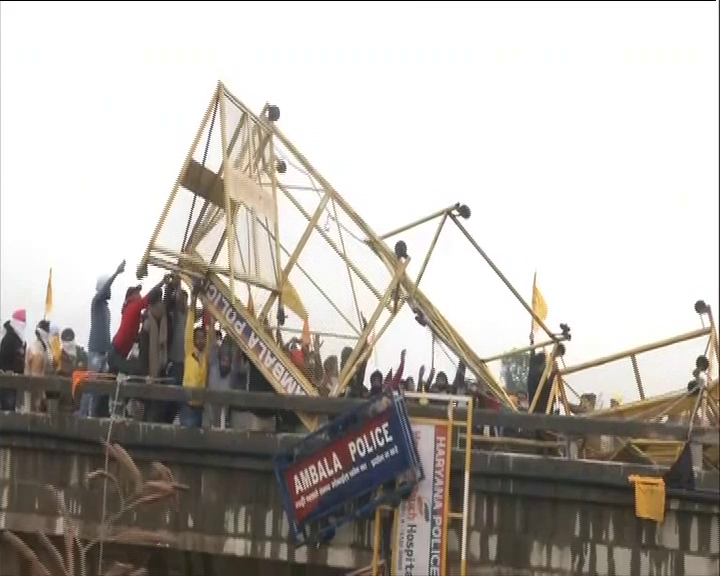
[138,82,558,418]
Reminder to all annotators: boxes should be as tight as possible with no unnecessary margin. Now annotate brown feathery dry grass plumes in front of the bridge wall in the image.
[0,443,187,576]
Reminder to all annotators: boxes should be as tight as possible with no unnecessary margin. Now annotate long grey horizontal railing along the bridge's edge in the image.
[0,374,720,446]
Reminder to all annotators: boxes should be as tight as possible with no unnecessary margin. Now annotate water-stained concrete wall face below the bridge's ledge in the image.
[0,416,720,576]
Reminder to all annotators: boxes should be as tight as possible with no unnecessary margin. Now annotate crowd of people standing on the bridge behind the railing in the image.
[0,262,707,431]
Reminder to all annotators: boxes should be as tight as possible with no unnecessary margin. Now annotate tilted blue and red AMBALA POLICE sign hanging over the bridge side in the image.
[275,392,424,545]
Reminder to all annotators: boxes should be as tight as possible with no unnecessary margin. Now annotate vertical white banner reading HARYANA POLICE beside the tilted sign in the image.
[392,422,451,576]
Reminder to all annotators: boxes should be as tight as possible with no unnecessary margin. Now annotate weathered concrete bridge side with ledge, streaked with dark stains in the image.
[0,378,720,576]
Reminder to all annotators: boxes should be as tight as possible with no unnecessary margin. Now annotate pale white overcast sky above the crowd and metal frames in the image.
[0,2,719,399]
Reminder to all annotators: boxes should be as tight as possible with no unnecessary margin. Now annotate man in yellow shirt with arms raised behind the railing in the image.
[180,292,212,428]
